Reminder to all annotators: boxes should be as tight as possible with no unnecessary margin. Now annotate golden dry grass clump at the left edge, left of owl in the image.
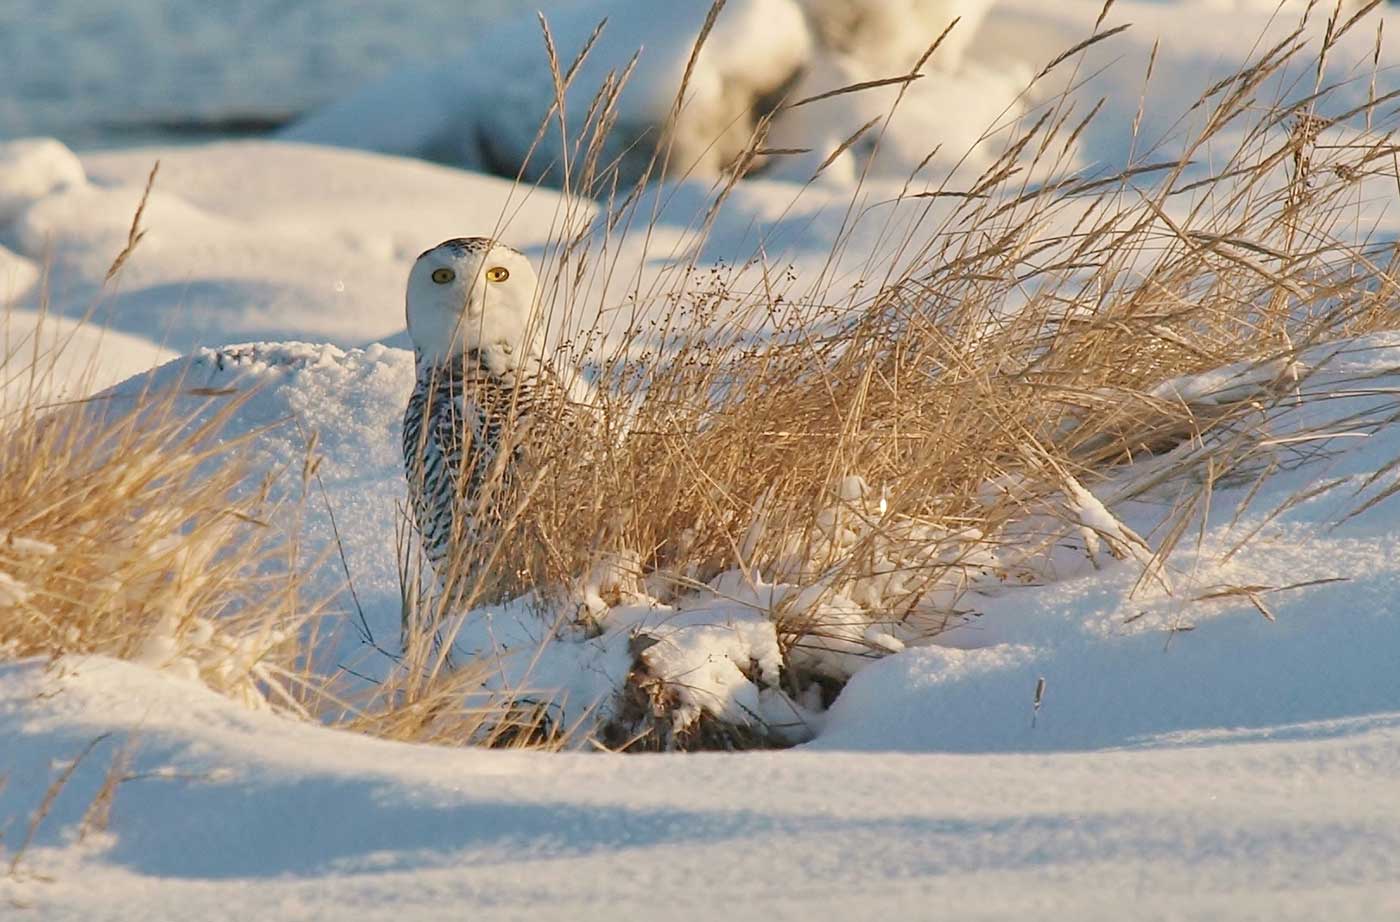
[0,344,315,711]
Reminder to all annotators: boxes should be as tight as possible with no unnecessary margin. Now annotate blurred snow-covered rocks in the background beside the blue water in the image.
[283,0,1400,185]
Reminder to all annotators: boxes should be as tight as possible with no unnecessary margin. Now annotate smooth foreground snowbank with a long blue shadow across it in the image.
[0,651,1400,922]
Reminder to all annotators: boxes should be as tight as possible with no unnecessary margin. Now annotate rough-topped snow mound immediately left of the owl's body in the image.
[104,343,413,670]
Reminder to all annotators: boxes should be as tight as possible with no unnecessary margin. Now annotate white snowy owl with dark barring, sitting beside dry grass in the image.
[403,236,579,585]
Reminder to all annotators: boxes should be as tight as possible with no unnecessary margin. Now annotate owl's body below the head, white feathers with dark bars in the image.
[403,350,559,583]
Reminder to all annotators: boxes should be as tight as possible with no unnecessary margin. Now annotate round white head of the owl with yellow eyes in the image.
[406,236,540,365]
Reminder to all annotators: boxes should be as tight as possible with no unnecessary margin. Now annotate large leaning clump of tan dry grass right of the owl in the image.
[397,4,1400,749]
